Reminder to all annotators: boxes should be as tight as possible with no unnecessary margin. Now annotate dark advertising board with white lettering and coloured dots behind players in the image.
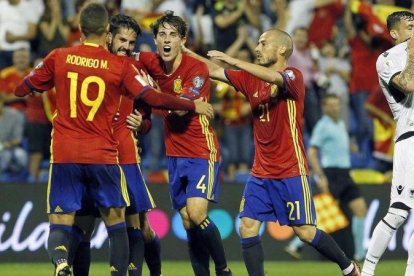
[0,183,414,262]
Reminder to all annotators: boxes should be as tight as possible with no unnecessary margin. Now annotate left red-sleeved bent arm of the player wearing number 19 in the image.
[14,50,57,97]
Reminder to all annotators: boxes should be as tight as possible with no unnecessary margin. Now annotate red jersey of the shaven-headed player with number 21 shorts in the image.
[225,67,308,179]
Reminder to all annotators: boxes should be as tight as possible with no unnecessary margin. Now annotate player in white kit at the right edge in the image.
[361,11,414,276]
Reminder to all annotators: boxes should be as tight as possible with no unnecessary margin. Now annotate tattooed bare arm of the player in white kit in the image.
[390,38,414,94]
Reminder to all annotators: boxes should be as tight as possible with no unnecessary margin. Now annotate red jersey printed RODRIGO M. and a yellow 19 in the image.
[21,43,157,164]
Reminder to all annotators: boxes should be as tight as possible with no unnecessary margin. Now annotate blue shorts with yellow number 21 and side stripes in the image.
[240,176,316,225]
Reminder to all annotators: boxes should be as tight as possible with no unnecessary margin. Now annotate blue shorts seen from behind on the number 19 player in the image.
[47,163,129,214]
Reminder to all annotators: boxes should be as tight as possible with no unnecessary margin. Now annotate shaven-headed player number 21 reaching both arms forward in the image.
[186,29,360,275]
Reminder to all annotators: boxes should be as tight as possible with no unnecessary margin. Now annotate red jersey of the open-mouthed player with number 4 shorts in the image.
[137,52,220,161]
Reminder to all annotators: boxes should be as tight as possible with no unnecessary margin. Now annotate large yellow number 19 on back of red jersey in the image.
[67,72,106,121]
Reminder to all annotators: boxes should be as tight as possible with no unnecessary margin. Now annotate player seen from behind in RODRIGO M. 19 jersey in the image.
[15,3,212,275]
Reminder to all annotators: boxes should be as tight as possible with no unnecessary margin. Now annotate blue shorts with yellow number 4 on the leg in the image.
[168,157,219,210]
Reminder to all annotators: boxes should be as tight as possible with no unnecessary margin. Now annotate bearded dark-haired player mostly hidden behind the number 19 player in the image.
[71,14,161,276]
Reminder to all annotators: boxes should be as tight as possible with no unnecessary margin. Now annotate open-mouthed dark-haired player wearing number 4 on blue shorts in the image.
[137,12,231,275]
